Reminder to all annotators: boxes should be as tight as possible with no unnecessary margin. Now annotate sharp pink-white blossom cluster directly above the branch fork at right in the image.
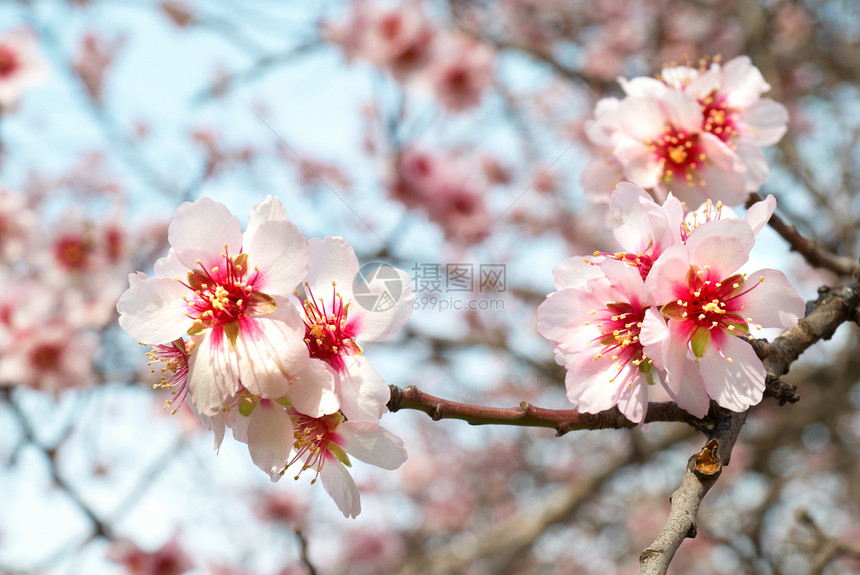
[538,182,804,423]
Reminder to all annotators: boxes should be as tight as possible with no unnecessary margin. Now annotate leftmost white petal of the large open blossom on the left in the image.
[116,278,192,345]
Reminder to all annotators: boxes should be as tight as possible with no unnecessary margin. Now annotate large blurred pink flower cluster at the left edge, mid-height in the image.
[0,186,150,396]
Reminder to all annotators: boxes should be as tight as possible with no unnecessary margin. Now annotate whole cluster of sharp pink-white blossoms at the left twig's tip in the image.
[117,197,414,517]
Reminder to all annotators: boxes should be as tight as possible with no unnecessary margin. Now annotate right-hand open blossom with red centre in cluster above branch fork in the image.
[641,219,804,411]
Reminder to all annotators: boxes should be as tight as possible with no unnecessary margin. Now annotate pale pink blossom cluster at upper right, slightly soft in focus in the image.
[581,56,788,205]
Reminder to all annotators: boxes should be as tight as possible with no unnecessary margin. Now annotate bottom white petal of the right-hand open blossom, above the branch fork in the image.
[699,336,766,411]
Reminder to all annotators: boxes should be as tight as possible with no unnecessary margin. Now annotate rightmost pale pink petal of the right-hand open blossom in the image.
[738,269,806,329]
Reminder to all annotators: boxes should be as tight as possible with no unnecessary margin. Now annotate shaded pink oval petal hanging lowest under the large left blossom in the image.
[248,401,293,481]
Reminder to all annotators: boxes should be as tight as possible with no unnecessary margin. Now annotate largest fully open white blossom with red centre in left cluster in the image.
[117,197,338,416]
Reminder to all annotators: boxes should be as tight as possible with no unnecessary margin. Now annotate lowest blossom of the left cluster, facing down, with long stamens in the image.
[288,410,406,517]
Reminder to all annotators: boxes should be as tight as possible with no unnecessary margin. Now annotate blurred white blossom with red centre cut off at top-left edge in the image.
[0,29,48,112]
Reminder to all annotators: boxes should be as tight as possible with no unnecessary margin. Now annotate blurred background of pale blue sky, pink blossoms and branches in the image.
[0,0,860,575]
